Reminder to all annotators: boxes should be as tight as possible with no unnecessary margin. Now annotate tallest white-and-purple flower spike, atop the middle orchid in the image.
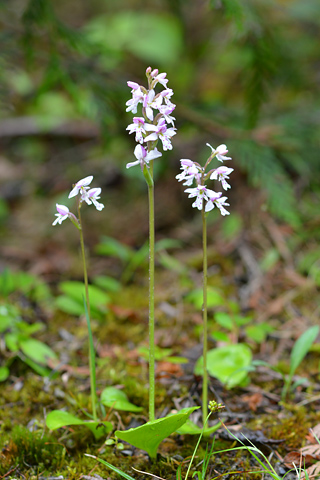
[126,67,176,170]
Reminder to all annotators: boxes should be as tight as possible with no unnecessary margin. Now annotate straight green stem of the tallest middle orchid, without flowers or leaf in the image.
[148,171,155,421]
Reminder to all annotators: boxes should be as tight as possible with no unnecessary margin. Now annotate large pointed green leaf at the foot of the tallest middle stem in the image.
[115,407,200,458]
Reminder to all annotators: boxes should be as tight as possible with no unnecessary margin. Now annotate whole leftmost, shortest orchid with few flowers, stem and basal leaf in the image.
[46,175,112,438]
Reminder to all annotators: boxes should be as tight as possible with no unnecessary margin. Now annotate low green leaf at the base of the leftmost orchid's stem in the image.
[46,410,113,439]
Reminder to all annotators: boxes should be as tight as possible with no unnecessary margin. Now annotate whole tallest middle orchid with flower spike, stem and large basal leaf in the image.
[115,67,198,458]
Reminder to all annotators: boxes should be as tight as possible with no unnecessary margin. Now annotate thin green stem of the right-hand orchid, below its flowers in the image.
[202,206,208,424]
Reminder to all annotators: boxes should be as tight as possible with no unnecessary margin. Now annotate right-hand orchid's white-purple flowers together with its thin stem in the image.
[176,143,233,424]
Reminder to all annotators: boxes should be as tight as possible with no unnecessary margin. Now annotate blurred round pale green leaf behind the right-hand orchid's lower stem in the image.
[194,343,252,388]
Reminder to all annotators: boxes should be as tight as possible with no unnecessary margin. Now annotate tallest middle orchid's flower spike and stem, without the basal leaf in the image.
[126,67,176,421]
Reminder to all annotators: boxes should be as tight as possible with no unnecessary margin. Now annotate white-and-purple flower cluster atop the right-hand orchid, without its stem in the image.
[176,143,233,215]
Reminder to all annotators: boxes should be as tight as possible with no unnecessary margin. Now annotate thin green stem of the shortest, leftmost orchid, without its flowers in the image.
[78,204,98,420]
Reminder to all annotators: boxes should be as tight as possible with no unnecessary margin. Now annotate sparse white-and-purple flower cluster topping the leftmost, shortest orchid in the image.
[52,175,104,228]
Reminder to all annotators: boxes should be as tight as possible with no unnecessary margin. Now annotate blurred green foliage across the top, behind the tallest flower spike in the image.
[0,0,320,225]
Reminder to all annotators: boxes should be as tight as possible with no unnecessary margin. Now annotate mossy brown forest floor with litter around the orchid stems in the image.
[0,140,320,480]
